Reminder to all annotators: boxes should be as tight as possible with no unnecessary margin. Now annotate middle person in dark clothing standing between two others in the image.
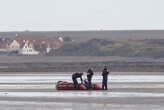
[87,67,94,89]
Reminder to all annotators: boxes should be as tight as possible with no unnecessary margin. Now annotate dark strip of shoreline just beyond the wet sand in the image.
[0,62,164,72]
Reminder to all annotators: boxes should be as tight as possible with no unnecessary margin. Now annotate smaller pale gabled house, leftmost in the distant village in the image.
[8,40,20,52]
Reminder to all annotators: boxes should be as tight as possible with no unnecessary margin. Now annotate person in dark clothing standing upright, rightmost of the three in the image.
[102,66,109,90]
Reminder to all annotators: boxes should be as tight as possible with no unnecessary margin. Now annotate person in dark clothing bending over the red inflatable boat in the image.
[72,72,83,89]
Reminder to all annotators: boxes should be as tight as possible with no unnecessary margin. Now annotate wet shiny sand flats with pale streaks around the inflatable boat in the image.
[0,73,164,110]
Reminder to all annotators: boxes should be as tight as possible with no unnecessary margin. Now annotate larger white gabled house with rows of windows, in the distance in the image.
[19,41,40,55]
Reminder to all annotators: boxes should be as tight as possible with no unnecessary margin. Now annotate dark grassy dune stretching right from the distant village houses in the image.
[49,39,164,59]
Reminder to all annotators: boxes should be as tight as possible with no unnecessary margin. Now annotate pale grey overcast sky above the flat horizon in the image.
[0,0,164,31]
